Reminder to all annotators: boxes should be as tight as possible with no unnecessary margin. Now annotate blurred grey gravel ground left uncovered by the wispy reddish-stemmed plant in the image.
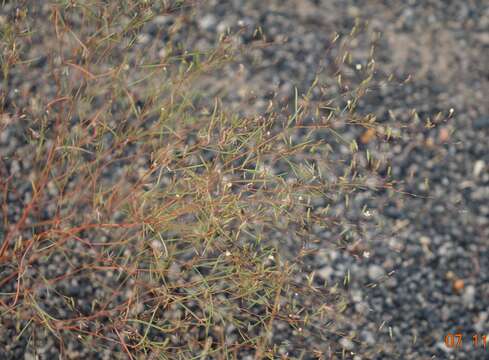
[0,0,489,359]
